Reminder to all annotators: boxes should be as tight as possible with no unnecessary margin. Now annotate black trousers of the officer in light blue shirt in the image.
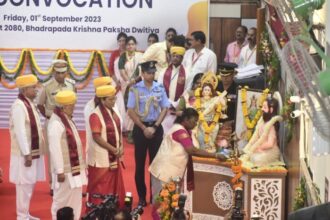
[133,123,164,199]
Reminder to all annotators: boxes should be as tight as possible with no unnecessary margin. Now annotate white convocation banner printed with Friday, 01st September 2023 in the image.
[0,0,209,50]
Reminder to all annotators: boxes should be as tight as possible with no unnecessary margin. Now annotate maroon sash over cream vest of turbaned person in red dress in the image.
[99,102,120,164]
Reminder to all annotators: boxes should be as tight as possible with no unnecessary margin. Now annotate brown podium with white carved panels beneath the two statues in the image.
[184,157,287,220]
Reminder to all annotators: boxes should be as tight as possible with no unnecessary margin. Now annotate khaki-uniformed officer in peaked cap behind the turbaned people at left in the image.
[37,59,76,195]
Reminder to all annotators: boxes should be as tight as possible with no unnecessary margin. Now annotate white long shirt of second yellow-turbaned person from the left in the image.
[47,115,87,189]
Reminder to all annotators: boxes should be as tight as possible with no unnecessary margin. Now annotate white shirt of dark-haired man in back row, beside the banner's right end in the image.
[182,47,217,89]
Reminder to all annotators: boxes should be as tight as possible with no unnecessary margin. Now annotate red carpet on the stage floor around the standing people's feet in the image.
[0,129,152,220]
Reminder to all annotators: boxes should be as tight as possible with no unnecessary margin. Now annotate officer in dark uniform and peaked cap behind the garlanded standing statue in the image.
[217,63,237,125]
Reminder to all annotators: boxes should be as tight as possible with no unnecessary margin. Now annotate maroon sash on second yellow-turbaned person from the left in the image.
[54,107,80,176]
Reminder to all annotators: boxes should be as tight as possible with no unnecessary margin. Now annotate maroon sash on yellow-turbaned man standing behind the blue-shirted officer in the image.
[163,64,186,101]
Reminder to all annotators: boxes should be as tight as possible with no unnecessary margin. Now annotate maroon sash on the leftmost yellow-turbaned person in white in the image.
[18,93,40,159]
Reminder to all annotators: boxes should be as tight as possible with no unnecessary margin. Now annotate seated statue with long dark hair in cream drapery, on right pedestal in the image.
[241,98,282,167]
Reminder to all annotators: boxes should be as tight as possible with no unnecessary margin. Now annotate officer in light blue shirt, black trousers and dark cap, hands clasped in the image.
[127,61,170,206]
